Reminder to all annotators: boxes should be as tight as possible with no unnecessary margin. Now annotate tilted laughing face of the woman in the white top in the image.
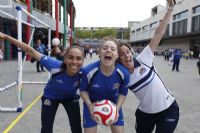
[119,45,134,71]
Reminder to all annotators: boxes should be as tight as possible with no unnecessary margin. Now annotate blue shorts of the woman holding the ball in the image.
[83,103,124,128]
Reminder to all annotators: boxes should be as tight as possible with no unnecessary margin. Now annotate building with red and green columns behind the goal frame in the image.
[0,0,73,60]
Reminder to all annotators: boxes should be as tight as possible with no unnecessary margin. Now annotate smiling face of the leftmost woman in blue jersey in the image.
[64,48,84,76]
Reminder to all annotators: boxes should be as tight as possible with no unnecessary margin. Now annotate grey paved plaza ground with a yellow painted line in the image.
[0,56,200,133]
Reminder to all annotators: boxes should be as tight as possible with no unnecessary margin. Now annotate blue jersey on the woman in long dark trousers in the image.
[40,56,81,99]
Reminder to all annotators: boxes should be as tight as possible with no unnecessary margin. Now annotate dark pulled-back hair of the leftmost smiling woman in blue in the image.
[60,45,84,71]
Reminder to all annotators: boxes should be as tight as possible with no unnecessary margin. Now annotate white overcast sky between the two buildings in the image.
[73,0,166,27]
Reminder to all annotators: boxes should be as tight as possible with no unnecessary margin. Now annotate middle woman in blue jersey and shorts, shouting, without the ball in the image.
[80,37,129,133]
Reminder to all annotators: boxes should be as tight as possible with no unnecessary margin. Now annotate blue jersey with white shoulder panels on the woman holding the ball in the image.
[80,61,129,103]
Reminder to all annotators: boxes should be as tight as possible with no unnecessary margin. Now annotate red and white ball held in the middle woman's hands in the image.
[93,100,117,126]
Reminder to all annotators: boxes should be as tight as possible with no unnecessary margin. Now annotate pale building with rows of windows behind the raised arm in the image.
[130,0,200,57]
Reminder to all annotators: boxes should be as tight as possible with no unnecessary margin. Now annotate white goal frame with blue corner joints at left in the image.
[0,4,51,112]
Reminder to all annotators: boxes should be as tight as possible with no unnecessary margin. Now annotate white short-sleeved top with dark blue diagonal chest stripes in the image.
[129,45,174,113]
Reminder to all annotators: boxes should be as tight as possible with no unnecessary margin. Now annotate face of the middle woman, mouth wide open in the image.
[100,41,118,67]
